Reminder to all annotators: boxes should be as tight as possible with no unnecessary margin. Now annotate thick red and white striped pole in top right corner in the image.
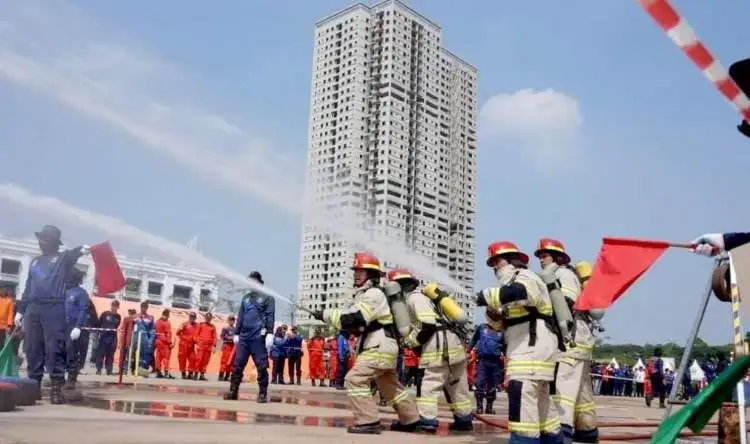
[638,0,750,122]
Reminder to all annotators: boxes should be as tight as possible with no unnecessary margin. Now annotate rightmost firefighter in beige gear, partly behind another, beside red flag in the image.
[534,239,599,444]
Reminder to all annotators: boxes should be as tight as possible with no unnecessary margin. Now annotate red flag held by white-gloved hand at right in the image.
[574,237,670,310]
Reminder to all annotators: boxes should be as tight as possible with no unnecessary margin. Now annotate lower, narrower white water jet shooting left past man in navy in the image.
[0,184,305,310]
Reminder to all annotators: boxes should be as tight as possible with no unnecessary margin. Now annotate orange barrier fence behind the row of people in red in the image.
[91,296,309,381]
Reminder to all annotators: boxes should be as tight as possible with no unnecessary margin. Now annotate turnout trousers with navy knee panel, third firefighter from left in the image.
[508,379,562,444]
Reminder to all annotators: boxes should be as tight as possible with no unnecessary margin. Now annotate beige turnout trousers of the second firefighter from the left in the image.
[417,361,474,421]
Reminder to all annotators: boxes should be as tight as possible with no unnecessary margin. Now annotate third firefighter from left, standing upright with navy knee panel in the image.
[477,241,562,444]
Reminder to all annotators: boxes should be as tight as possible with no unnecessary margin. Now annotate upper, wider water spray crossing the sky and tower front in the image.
[0,0,465,291]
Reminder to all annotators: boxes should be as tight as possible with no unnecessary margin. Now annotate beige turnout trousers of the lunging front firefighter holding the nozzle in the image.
[344,359,419,425]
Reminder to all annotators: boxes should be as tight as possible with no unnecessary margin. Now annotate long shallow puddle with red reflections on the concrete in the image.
[72,397,494,436]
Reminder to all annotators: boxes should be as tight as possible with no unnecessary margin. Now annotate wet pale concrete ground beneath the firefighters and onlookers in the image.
[0,376,715,444]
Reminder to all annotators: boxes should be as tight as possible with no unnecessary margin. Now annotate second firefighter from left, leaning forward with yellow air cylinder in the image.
[388,269,473,433]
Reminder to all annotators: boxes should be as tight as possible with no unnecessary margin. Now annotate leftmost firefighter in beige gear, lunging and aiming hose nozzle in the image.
[314,253,419,434]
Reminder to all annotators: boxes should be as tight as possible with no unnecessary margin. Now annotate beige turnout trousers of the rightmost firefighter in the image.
[552,358,599,443]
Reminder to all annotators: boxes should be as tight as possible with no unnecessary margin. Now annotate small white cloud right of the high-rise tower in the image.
[479,88,583,165]
